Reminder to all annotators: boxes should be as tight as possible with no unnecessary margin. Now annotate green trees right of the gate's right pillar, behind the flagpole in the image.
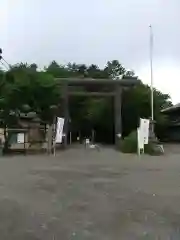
[122,83,172,136]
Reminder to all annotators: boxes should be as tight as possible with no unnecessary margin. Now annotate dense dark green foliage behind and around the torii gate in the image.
[0,60,171,142]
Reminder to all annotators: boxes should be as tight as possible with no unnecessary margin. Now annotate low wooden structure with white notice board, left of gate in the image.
[0,112,47,152]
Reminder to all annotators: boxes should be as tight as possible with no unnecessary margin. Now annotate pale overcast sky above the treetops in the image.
[0,0,180,103]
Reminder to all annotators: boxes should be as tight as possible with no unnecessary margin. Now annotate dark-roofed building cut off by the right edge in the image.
[161,103,180,142]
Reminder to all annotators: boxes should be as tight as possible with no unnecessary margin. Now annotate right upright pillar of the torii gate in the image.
[114,84,122,148]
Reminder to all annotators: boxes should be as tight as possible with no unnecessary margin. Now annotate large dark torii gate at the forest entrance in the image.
[56,77,139,147]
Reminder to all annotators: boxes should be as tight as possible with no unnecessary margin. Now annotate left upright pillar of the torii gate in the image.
[63,83,69,148]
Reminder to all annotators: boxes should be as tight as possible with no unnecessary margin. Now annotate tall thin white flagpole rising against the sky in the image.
[149,25,154,125]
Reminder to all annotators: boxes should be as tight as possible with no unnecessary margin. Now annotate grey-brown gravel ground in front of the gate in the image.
[0,148,180,240]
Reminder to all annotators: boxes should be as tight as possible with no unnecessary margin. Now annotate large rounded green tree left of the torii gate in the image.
[1,64,60,124]
